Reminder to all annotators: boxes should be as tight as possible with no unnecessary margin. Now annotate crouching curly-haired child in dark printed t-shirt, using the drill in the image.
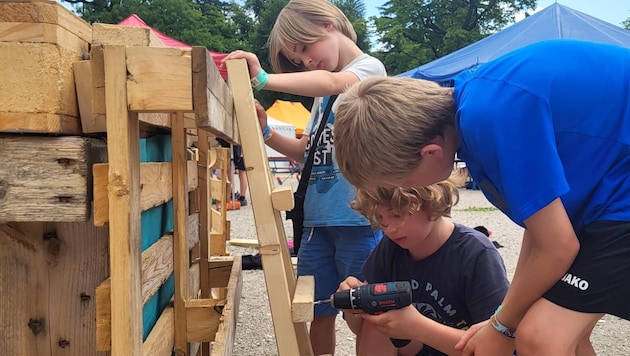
[339,181,508,356]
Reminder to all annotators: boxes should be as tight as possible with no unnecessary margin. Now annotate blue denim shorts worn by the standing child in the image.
[297,226,383,316]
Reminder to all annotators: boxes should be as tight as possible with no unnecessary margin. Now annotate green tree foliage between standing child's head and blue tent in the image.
[372,0,536,74]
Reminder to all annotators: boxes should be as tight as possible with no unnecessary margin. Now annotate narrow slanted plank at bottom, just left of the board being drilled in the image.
[211,254,243,356]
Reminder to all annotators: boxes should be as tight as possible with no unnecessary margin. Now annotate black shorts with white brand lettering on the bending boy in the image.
[544,221,630,320]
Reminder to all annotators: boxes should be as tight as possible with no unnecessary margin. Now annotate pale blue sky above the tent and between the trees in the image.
[363,0,630,26]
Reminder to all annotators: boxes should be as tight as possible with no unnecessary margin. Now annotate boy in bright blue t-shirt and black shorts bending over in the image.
[334,40,630,356]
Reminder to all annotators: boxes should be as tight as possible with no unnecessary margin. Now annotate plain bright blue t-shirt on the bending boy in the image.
[454,40,630,230]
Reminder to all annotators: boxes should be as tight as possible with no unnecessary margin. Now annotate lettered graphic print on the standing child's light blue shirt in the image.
[307,97,339,193]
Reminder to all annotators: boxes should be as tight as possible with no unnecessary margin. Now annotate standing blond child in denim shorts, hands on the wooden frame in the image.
[224,0,386,355]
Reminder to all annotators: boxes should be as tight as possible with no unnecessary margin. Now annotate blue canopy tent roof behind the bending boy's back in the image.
[398,3,630,86]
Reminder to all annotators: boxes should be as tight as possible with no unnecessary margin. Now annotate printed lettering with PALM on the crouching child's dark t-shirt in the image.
[411,279,470,329]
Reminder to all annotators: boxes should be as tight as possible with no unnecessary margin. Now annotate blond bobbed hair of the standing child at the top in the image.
[267,0,357,73]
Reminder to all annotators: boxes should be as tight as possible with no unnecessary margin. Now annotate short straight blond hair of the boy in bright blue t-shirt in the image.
[334,77,455,189]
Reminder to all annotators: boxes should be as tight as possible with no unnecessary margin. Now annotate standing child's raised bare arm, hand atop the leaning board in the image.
[221,51,359,97]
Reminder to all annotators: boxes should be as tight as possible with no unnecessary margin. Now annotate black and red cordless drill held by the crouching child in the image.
[315,281,411,314]
